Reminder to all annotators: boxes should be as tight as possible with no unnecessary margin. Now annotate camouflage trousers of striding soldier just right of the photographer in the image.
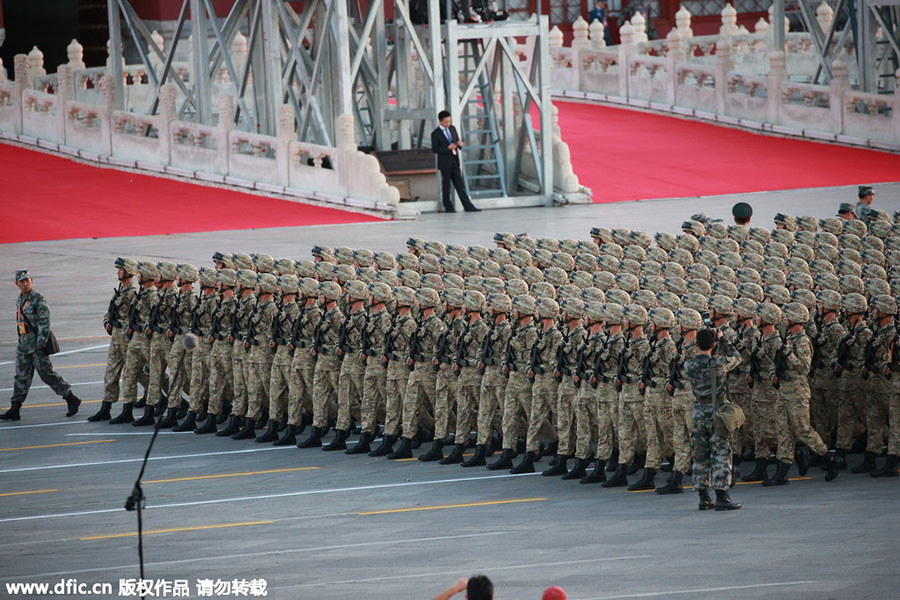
[775,377,828,464]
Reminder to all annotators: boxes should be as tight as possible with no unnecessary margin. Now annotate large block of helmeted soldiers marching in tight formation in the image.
[89,209,900,494]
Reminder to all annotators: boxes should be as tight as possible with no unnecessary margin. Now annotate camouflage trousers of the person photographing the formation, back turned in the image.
[691,402,731,490]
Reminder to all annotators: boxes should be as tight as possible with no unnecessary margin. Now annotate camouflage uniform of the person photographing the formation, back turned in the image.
[684,349,741,490]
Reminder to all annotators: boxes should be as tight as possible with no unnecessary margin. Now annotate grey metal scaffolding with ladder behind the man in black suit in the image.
[108,0,553,203]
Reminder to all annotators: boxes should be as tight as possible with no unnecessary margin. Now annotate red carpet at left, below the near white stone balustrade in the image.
[0,144,380,244]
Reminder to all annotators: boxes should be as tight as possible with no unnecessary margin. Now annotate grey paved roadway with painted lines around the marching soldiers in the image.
[0,184,900,600]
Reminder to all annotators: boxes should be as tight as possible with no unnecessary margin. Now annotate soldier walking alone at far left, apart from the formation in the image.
[0,269,81,421]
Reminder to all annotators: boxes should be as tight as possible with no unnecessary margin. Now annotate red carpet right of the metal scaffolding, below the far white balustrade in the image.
[554,101,900,203]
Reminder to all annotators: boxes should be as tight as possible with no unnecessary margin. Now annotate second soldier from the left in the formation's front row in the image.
[109,261,159,425]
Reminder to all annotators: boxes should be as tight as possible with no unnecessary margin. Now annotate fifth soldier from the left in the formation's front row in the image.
[172,267,219,431]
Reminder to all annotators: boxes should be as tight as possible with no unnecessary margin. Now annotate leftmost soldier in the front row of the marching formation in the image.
[88,257,139,423]
